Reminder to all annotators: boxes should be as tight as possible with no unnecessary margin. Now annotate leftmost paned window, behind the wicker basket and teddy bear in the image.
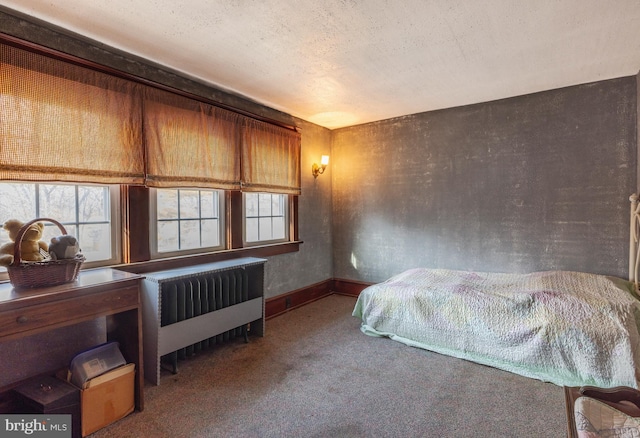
[0,182,119,267]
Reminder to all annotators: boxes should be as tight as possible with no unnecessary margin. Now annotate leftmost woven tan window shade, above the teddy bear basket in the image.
[0,45,144,184]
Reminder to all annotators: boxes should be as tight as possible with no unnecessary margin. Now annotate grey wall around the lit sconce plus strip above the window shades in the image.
[0,6,333,297]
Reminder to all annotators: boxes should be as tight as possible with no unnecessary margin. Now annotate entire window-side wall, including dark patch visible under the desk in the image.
[0,6,333,387]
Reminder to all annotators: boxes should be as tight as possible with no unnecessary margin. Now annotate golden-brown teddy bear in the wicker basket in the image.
[0,219,49,266]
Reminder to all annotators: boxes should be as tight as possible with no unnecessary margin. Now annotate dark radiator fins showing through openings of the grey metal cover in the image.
[160,269,249,374]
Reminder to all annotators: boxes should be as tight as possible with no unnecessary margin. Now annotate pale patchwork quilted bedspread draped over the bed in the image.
[353,269,640,388]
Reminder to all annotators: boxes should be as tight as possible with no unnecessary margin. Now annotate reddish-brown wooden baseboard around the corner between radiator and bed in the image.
[264,279,372,319]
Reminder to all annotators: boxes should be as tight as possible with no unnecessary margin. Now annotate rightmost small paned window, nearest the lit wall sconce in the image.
[244,193,289,245]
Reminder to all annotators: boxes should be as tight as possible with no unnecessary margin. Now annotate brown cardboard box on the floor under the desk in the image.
[80,363,135,437]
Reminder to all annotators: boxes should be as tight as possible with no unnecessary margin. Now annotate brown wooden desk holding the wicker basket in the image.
[0,268,144,411]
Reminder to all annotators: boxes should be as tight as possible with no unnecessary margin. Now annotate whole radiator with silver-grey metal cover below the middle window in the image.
[142,257,266,385]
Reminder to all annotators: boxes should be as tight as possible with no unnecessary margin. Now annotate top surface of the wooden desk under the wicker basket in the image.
[0,268,143,310]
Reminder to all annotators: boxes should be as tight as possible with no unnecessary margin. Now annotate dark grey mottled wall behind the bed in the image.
[332,76,637,282]
